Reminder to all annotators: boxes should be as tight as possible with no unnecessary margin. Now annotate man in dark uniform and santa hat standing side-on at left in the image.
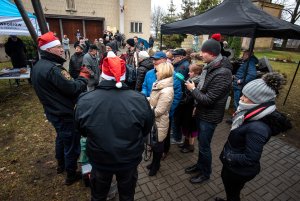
[32,32,88,185]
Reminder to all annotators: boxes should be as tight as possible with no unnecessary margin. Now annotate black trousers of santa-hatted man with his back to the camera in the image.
[91,167,138,201]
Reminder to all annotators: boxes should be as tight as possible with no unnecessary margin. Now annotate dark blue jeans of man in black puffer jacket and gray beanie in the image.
[197,119,217,178]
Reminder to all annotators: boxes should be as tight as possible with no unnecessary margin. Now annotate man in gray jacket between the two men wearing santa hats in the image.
[82,45,100,91]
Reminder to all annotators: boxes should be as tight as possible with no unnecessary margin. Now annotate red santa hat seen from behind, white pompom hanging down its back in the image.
[101,51,126,88]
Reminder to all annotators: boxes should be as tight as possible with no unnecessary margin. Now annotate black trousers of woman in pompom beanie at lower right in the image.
[221,166,256,201]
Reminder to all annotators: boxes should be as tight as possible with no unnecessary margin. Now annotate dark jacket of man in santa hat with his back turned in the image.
[75,80,154,171]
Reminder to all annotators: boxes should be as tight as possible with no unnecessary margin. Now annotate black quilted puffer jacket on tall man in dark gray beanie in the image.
[192,57,232,124]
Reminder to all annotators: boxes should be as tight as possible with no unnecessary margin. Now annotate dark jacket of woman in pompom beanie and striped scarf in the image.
[220,111,291,176]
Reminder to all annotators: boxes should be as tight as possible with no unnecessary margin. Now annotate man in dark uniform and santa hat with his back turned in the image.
[75,51,154,201]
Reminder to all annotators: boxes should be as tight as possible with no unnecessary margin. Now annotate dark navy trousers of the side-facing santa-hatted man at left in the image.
[46,113,80,172]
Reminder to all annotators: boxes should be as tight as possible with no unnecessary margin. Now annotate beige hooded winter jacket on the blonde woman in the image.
[149,76,174,142]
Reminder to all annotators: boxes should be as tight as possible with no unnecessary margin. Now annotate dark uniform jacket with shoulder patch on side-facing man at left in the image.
[32,51,87,118]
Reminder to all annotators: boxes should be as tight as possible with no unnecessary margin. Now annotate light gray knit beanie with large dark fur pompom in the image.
[242,72,286,104]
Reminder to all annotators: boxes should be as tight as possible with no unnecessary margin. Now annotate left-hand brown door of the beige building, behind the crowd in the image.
[62,19,83,44]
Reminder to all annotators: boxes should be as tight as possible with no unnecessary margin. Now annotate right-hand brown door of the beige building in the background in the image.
[85,20,103,43]
